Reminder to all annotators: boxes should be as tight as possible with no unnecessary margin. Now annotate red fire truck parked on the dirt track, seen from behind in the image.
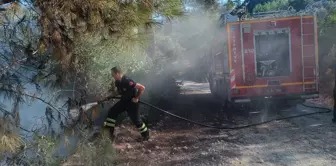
[209,11,319,103]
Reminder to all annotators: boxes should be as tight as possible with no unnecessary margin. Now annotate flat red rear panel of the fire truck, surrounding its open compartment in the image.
[227,16,318,101]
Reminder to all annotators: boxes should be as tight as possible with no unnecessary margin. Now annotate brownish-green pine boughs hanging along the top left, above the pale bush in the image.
[36,0,183,74]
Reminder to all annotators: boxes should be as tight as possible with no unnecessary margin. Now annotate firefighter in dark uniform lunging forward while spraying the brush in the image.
[89,67,149,141]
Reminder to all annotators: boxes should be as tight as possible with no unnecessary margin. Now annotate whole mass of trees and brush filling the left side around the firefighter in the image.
[0,0,223,165]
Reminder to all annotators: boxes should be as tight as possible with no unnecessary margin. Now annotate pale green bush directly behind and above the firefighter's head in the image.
[74,32,151,94]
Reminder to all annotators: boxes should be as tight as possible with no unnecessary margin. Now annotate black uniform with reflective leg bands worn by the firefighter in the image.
[105,76,149,138]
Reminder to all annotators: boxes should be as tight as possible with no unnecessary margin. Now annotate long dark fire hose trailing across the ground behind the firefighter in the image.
[93,97,332,130]
